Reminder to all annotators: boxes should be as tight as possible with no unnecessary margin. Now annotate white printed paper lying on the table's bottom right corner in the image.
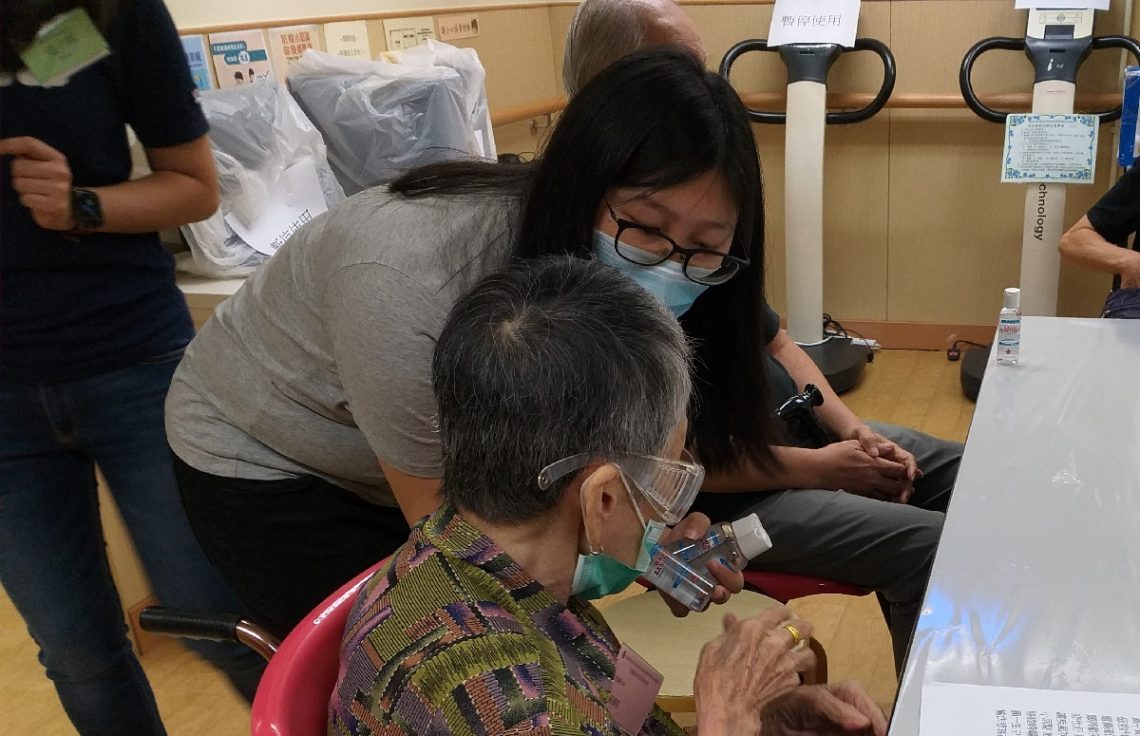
[919,682,1140,736]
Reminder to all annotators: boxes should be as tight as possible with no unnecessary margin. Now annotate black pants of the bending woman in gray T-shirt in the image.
[174,456,410,637]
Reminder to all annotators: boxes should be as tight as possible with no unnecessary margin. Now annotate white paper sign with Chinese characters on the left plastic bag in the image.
[226,156,328,255]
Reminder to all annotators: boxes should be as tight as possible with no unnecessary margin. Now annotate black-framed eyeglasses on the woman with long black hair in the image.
[605,202,749,286]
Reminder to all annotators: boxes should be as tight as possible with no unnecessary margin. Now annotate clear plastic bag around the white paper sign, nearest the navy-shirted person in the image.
[182,81,344,278]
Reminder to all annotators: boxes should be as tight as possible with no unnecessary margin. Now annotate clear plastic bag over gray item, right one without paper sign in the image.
[288,43,495,196]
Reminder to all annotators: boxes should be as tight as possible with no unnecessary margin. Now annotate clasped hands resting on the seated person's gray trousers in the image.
[815,440,913,501]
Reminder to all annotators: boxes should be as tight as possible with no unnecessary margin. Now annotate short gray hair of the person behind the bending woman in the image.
[562,0,646,95]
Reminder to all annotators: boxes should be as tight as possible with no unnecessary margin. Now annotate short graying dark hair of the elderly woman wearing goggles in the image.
[432,256,692,523]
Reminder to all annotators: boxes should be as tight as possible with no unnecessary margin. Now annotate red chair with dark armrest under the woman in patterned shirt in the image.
[139,559,388,736]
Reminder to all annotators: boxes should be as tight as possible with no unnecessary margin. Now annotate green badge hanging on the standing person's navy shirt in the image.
[19,8,111,87]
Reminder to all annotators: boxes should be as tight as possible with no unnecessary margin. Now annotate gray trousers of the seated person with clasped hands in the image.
[693,422,962,671]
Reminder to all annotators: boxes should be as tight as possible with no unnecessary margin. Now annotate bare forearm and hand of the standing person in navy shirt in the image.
[0,136,218,232]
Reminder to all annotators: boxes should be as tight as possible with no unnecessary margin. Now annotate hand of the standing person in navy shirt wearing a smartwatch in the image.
[0,136,75,231]
